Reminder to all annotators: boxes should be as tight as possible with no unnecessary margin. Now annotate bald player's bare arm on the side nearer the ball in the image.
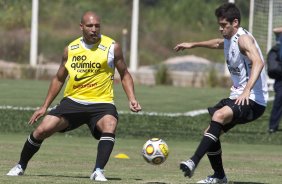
[114,43,141,112]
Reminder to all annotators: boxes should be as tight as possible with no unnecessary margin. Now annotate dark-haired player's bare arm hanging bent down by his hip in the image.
[235,35,264,105]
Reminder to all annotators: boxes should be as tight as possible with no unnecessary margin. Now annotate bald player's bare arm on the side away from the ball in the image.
[29,47,68,124]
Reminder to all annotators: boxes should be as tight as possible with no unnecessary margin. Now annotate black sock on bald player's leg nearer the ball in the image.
[93,133,115,171]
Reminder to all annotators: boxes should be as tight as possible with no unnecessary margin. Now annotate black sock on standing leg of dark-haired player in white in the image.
[207,140,225,179]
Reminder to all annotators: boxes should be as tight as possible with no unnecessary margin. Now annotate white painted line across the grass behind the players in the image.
[0,97,274,117]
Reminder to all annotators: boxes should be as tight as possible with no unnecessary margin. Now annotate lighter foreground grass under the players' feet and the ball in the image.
[0,134,282,184]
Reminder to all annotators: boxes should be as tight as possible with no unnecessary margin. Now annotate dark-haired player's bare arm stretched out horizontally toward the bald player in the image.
[174,38,224,52]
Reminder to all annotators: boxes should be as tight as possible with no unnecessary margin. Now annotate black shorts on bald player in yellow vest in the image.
[48,98,118,140]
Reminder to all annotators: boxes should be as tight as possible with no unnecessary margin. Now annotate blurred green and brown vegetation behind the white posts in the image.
[0,0,249,65]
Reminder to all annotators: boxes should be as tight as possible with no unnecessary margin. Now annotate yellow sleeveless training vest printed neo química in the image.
[64,35,115,103]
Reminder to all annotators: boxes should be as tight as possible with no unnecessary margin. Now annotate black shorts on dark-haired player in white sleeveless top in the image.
[208,98,265,132]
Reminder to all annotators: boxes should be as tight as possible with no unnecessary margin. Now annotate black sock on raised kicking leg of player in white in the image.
[191,121,222,166]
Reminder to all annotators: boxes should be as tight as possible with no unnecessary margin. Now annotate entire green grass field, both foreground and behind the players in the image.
[0,79,282,184]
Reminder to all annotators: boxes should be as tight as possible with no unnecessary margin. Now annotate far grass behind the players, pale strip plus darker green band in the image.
[0,79,282,145]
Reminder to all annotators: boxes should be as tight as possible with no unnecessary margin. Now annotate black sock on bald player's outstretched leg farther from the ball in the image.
[18,133,43,170]
